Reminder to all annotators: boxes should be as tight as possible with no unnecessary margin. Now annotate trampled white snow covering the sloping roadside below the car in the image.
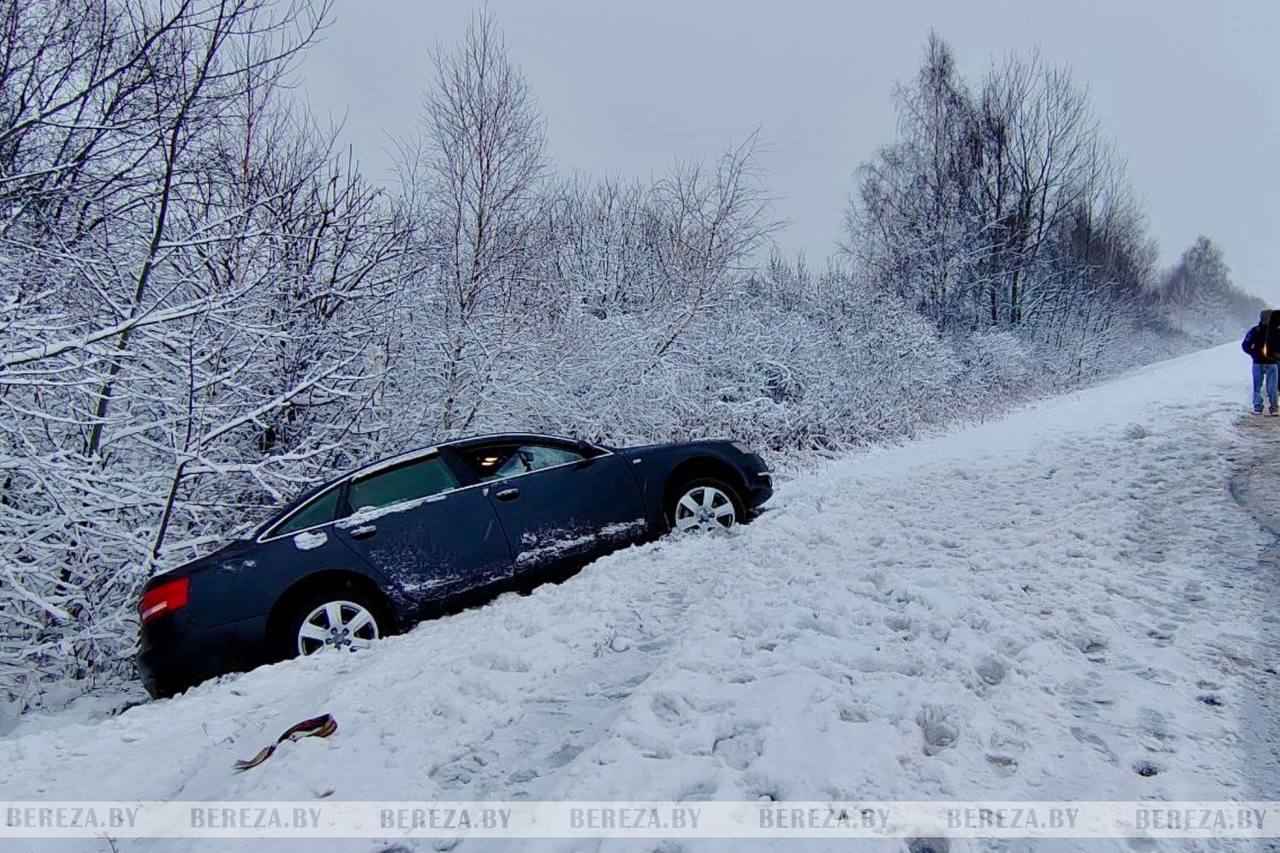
[0,347,1280,852]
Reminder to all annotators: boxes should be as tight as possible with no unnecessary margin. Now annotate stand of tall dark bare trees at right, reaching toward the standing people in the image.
[845,35,1261,363]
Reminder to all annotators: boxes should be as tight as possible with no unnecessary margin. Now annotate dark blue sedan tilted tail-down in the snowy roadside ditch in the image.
[138,433,773,697]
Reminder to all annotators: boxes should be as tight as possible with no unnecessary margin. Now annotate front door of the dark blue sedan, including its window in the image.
[456,439,646,575]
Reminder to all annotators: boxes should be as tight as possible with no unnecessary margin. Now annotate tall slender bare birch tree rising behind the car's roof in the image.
[401,12,548,433]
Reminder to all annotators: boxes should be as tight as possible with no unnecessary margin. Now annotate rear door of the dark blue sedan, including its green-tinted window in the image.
[334,451,512,610]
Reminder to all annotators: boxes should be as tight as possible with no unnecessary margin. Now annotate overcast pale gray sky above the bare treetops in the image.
[301,0,1280,302]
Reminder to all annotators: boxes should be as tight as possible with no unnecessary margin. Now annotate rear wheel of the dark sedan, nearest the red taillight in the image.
[273,585,392,660]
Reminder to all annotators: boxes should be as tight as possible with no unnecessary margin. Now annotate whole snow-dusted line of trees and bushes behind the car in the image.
[0,0,1256,712]
